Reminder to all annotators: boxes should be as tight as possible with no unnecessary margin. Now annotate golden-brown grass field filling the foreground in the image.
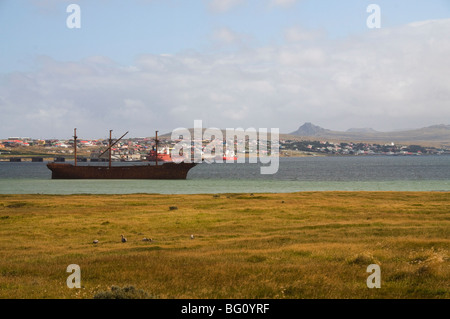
[0,192,450,299]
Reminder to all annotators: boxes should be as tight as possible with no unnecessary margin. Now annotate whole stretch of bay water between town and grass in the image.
[0,155,450,194]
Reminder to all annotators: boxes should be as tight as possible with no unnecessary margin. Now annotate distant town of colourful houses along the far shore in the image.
[0,137,450,161]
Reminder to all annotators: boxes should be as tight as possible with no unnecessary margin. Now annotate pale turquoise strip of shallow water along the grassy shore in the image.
[0,179,450,194]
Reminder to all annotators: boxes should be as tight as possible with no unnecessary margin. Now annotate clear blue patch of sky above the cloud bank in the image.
[0,0,450,72]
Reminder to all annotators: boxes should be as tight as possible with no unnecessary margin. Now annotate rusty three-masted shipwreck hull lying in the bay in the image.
[47,129,197,179]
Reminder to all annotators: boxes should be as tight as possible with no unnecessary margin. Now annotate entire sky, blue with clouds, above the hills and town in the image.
[0,0,450,138]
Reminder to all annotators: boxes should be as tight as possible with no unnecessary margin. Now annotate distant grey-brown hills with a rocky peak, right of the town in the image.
[285,123,450,146]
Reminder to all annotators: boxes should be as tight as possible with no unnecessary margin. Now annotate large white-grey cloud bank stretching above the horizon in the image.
[0,19,450,137]
